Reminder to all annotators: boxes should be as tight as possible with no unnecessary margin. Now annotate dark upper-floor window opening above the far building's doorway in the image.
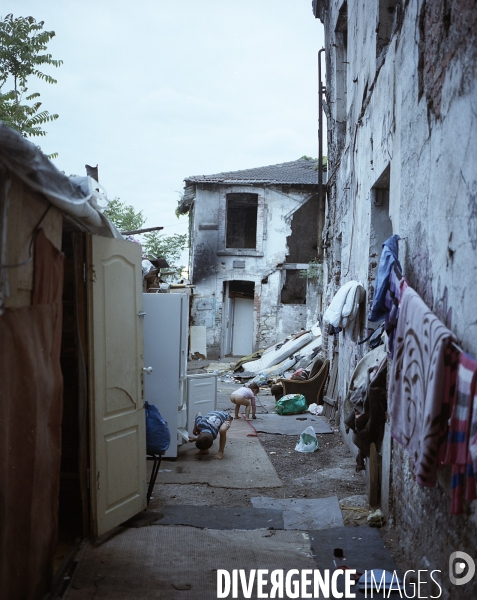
[226,194,258,248]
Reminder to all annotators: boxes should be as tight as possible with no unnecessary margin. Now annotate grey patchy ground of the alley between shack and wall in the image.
[63,358,402,600]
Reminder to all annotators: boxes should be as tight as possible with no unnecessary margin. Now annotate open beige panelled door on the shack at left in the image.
[88,236,146,535]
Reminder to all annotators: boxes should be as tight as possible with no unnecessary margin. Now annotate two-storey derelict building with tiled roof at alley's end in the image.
[180,158,322,357]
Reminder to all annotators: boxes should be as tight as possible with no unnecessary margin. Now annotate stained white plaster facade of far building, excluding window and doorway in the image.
[191,184,317,357]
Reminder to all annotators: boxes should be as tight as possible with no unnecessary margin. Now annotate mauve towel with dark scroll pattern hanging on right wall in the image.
[389,287,453,487]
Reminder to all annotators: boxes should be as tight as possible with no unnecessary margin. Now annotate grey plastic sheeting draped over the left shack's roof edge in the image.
[0,122,123,239]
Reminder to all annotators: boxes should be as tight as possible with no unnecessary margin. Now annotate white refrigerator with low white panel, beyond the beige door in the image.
[143,293,217,458]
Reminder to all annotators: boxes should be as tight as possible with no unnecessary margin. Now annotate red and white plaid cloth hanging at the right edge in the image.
[444,352,477,515]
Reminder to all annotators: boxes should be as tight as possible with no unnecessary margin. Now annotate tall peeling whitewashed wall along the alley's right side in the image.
[318,0,477,600]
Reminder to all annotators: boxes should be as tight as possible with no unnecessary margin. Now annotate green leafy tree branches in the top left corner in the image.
[0,14,63,146]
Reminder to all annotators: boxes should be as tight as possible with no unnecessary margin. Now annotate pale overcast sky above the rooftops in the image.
[10,0,323,234]
